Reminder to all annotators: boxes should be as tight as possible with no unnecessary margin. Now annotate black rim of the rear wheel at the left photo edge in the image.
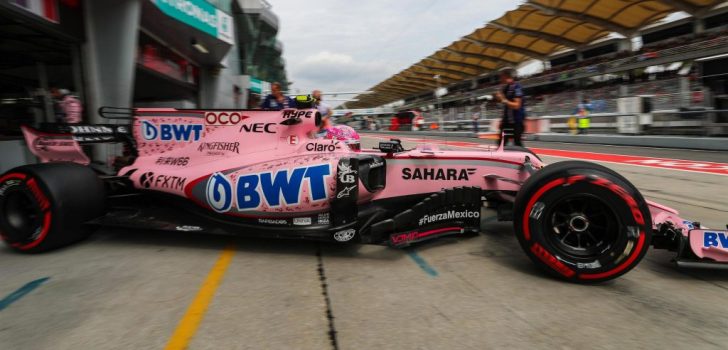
[2,190,42,242]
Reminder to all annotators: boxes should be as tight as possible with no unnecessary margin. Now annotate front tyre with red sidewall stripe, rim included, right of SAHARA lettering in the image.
[514,161,652,283]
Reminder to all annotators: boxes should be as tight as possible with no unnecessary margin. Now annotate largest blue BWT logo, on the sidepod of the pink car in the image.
[205,164,331,213]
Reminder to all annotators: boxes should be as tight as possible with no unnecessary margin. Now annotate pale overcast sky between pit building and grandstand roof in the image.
[268,0,520,97]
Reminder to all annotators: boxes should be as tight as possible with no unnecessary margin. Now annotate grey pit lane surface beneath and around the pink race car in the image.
[0,138,728,349]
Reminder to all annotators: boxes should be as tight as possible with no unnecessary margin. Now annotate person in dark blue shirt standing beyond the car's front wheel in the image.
[495,68,526,146]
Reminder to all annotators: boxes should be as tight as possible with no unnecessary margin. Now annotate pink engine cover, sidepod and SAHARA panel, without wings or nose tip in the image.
[120,109,528,217]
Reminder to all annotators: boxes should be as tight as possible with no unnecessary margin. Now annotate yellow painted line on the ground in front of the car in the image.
[165,246,235,350]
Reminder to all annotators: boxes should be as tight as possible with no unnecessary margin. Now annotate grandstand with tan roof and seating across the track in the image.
[345,0,728,134]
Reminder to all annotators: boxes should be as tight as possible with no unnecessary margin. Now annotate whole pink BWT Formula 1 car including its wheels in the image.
[0,108,728,282]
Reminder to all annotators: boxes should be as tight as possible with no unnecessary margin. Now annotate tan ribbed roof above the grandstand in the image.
[347,0,721,108]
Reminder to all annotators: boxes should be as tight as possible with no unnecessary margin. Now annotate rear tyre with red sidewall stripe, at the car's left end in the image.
[0,163,105,253]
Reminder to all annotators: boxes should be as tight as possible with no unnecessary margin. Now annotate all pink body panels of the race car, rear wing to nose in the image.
[23,108,728,261]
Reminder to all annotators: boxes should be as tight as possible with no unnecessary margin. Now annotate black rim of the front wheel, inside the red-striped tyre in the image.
[546,194,621,260]
